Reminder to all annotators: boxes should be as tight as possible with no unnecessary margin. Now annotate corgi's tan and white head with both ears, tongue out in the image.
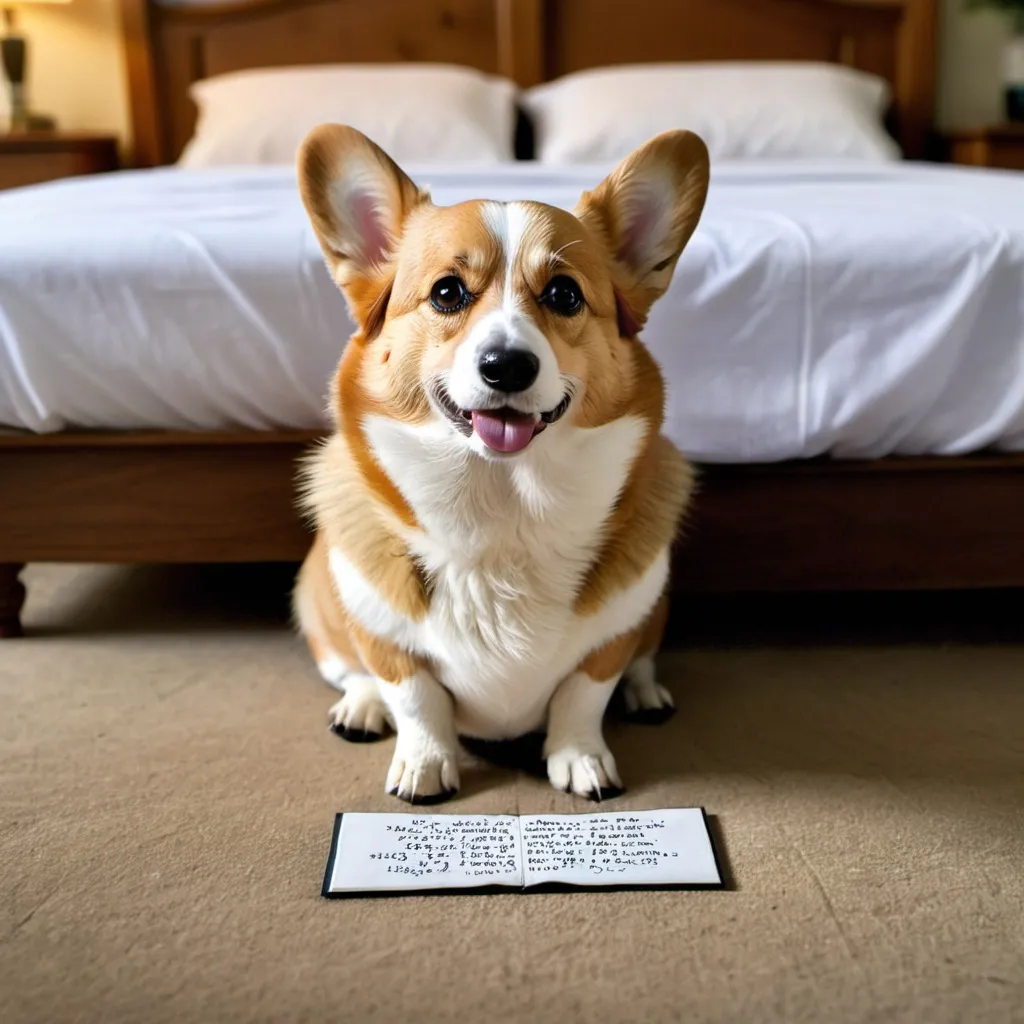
[299,125,709,458]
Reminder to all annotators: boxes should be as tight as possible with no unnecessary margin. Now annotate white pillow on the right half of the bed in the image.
[522,61,900,164]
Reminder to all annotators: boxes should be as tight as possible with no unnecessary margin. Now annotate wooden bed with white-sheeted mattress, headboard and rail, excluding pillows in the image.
[0,0,1024,634]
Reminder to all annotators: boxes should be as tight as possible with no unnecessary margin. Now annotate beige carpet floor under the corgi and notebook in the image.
[0,567,1024,1024]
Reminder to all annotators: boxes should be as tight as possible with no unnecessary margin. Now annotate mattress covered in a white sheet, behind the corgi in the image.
[0,164,1024,462]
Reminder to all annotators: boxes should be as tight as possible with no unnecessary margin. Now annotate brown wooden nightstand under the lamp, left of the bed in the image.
[0,132,119,188]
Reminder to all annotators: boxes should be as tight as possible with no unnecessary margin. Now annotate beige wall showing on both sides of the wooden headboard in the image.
[0,0,1009,157]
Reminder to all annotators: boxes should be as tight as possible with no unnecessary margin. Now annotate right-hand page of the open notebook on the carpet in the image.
[519,807,722,886]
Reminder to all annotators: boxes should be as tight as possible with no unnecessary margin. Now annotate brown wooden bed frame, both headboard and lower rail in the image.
[8,0,1024,635]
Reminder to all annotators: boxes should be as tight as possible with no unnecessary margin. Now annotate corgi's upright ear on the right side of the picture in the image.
[574,131,710,334]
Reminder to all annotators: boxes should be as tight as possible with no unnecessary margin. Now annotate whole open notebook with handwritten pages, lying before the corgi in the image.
[323,807,723,897]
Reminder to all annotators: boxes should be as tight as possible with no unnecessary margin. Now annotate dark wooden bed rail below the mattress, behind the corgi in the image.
[0,423,1024,634]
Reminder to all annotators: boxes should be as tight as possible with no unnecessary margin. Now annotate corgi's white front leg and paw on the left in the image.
[380,668,459,804]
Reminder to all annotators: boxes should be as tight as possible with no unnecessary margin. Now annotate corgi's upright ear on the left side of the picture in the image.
[298,125,429,334]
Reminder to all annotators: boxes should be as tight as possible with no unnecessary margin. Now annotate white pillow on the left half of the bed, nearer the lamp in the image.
[178,65,517,167]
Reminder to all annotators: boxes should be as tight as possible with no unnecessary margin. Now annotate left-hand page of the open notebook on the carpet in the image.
[326,813,522,893]
